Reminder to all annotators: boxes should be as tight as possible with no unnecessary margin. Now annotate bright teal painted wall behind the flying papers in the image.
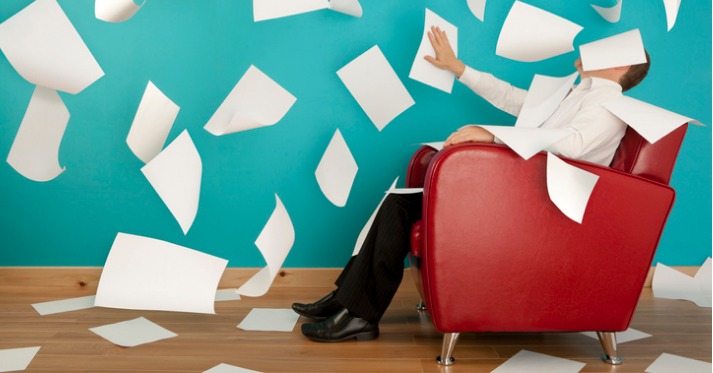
[0,0,712,267]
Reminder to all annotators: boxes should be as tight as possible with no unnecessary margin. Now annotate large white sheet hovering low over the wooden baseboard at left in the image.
[94,233,228,314]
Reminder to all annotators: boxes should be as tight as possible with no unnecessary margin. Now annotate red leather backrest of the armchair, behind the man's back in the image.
[609,123,688,184]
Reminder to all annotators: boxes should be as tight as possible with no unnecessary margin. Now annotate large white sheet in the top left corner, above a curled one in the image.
[0,0,104,94]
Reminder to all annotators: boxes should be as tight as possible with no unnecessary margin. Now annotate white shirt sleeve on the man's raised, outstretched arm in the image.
[458,66,527,116]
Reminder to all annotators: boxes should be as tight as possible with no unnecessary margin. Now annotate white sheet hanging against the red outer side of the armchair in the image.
[547,153,599,224]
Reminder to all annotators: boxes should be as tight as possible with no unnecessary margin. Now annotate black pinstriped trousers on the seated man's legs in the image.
[336,193,423,323]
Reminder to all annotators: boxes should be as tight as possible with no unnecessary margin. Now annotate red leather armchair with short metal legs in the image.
[407,125,687,365]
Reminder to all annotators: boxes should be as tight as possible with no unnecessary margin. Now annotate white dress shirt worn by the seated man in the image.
[458,66,626,166]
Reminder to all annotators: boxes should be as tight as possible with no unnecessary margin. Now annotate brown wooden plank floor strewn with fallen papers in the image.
[0,268,711,373]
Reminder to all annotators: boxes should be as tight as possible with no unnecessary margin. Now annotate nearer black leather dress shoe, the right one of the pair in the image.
[302,308,379,342]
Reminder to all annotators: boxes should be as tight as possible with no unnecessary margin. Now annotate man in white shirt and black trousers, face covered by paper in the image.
[292,27,649,342]
